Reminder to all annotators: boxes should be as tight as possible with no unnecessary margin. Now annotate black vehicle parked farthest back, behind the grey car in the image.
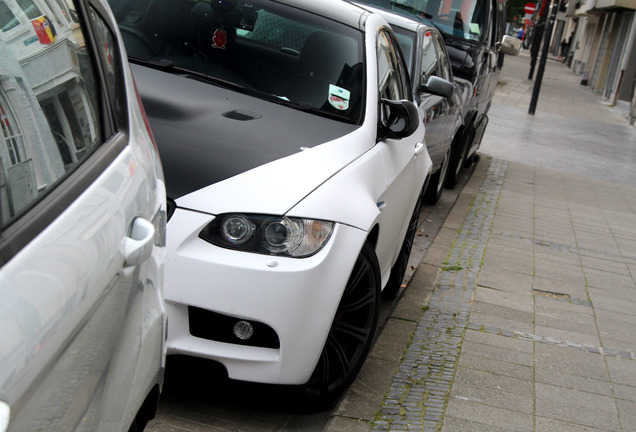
[366,0,521,187]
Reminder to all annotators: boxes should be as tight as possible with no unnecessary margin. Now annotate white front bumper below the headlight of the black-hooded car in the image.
[165,209,366,384]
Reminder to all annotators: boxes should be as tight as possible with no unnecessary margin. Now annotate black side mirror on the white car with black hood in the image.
[378,99,420,139]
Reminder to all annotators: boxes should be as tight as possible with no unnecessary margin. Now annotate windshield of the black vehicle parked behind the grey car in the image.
[363,0,490,42]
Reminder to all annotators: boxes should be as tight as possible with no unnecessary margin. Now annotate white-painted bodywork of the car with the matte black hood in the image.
[166,15,432,384]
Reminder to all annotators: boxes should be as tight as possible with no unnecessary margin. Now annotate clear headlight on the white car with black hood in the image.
[199,214,334,258]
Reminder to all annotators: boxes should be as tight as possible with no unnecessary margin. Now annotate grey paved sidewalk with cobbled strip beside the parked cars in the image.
[326,51,636,432]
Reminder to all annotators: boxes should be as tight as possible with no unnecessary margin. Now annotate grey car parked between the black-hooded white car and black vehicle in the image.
[365,6,472,204]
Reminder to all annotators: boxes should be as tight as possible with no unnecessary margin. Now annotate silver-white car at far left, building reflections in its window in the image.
[0,0,167,432]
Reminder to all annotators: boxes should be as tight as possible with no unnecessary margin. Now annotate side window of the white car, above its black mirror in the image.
[377,30,410,104]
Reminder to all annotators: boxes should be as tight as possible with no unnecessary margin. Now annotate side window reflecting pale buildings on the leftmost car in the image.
[0,0,126,250]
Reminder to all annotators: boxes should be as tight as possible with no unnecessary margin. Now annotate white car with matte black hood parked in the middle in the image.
[111,0,431,407]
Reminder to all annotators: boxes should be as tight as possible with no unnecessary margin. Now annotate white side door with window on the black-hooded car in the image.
[376,29,427,275]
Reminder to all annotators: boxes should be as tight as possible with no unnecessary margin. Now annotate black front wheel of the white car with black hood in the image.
[297,243,381,410]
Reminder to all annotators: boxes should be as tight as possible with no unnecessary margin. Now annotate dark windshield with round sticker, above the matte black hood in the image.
[109,0,364,124]
